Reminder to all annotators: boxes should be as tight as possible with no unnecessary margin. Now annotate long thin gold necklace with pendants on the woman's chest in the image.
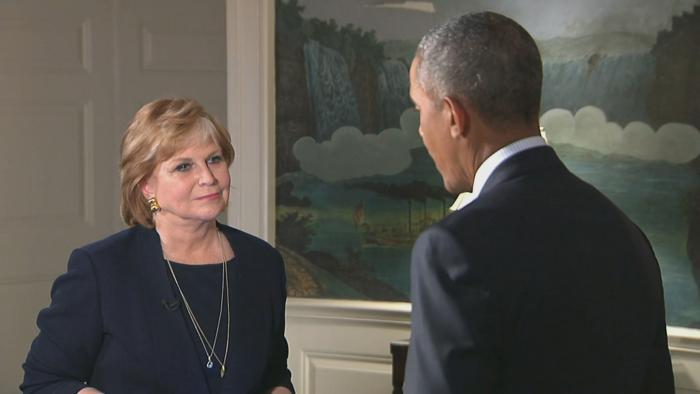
[163,231,231,378]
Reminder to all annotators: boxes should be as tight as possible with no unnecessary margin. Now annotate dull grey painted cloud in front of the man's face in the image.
[292,108,423,182]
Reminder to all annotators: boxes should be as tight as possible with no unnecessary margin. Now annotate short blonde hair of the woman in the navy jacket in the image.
[119,98,235,228]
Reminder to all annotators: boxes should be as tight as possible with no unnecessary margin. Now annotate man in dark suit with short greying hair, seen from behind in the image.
[404,13,674,394]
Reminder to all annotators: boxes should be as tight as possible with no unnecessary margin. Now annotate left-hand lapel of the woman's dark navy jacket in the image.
[133,228,209,393]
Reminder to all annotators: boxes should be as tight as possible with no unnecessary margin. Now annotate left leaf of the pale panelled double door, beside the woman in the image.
[0,0,117,393]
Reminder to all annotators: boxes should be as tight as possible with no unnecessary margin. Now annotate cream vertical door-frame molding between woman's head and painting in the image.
[226,0,275,243]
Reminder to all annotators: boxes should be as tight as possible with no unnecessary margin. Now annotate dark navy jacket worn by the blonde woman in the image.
[20,225,292,394]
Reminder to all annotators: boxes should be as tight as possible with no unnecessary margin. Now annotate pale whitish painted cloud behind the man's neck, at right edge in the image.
[540,106,700,163]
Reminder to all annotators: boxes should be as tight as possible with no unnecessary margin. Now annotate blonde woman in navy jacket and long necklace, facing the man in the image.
[20,99,294,394]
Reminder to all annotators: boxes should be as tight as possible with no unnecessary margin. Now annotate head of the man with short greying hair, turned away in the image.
[411,12,542,193]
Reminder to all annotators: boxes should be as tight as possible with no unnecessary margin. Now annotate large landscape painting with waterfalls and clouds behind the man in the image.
[274,0,700,328]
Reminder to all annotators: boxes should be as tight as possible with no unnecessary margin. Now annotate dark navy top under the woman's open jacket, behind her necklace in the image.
[166,257,236,394]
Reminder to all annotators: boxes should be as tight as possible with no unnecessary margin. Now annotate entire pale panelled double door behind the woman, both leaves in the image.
[0,0,226,394]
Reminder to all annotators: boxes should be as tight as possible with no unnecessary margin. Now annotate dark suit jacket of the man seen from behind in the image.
[404,147,674,394]
